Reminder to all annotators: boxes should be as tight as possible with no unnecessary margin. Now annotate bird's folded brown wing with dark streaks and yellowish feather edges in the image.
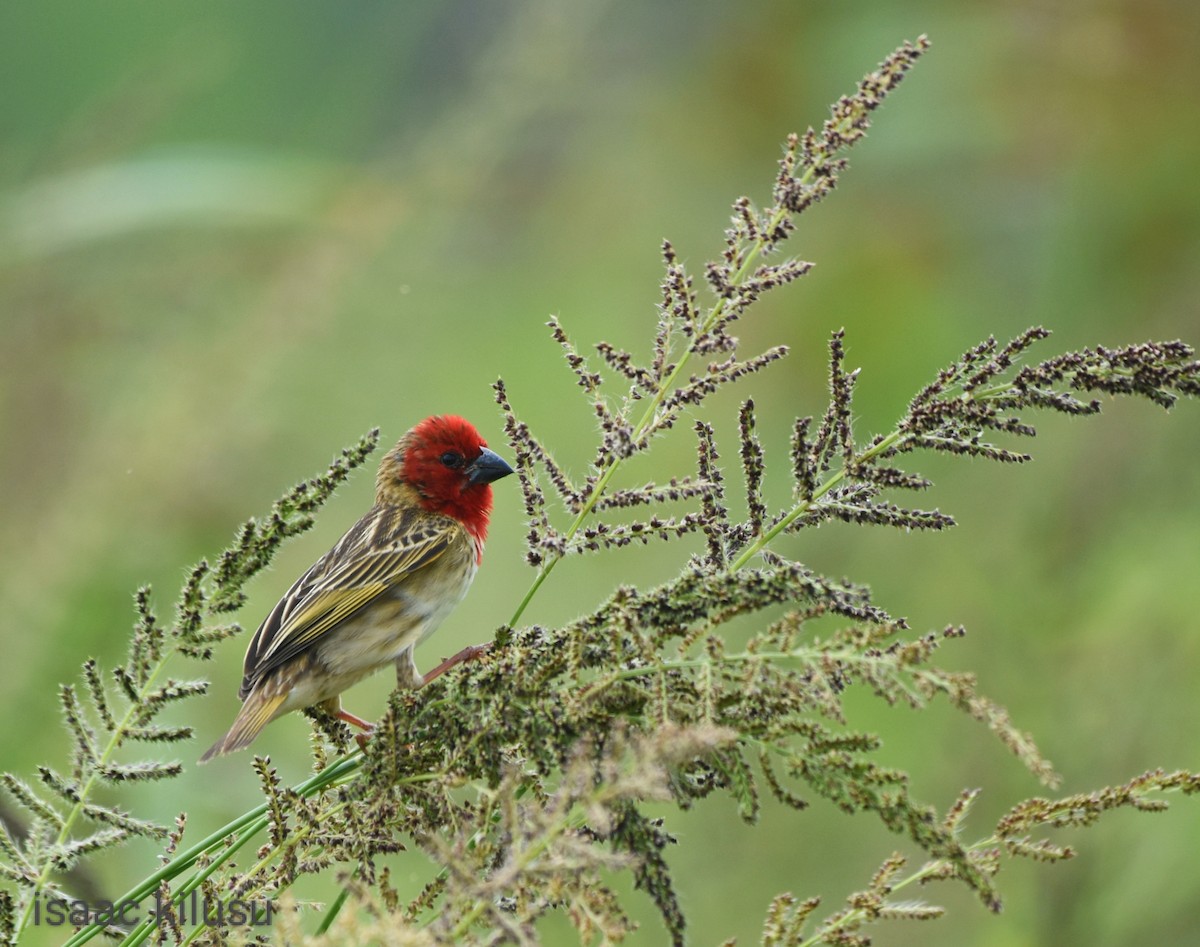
[240,507,461,699]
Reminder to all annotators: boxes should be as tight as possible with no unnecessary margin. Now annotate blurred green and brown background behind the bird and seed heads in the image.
[0,0,1200,947]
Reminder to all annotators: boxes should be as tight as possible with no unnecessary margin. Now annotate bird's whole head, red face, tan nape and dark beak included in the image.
[376,414,512,543]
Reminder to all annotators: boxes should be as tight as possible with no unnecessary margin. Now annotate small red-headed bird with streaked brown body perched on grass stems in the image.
[199,414,512,763]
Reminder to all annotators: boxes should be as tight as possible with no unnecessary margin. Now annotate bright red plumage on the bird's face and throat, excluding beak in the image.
[401,414,492,545]
